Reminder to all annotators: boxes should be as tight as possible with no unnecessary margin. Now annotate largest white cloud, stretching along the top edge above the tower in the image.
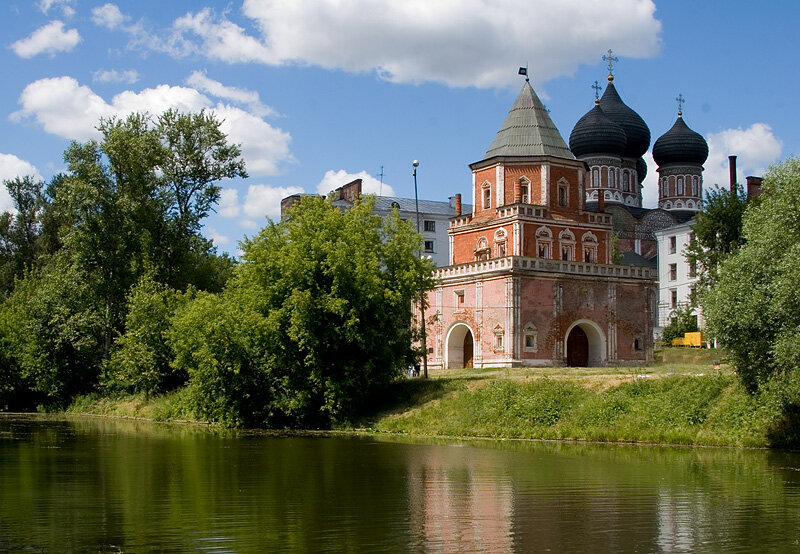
[155,0,661,88]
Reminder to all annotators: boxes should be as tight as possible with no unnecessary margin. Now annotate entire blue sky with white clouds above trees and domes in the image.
[0,0,800,254]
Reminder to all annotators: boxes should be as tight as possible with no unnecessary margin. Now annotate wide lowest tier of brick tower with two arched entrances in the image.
[426,256,655,369]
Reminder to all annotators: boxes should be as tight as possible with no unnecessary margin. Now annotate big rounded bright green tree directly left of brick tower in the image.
[170,197,433,427]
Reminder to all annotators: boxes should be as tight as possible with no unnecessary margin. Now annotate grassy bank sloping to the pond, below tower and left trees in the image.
[68,349,800,447]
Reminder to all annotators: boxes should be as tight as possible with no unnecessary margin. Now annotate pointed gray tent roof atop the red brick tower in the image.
[484,81,575,160]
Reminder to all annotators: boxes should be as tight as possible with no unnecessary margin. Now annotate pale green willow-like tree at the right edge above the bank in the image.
[704,154,800,391]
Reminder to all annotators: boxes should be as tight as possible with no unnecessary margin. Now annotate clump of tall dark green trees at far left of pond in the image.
[0,111,246,405]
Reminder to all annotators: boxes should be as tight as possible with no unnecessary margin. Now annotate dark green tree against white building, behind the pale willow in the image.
[684,185,748,303]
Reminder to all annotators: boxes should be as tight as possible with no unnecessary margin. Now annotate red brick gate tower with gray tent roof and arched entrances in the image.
[426,76,656,369]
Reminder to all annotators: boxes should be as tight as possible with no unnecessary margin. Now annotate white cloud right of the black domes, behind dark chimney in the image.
[703,123,783,190]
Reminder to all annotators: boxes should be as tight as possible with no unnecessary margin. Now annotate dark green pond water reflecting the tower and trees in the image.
[0,415,800,552]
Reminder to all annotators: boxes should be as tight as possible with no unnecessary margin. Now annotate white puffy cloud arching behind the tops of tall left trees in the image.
[11,77,294,175]
